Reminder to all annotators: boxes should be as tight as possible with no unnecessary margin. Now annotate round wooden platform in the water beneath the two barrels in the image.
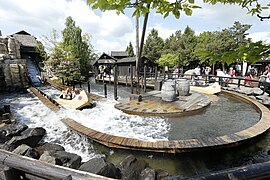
[115,91,211,116]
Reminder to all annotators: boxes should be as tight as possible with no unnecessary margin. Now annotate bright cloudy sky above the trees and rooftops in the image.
[0,0,270,54]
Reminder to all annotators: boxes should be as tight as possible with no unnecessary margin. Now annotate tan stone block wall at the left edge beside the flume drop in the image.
[0,36,29,91]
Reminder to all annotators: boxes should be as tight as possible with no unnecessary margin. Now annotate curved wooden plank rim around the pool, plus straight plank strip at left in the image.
[26,81,270,153]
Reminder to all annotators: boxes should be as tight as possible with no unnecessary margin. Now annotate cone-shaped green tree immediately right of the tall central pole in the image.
[143,29,164,61]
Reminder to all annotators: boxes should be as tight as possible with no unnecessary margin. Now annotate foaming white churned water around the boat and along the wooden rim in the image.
[0,88,170,161]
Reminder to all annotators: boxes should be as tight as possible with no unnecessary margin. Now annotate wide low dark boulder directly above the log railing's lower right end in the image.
[79,158,121,179]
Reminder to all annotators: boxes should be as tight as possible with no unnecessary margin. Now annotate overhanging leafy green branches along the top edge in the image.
[87,0,270,18]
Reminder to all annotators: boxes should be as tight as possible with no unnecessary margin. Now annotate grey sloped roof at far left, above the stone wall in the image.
[12,31,37,47]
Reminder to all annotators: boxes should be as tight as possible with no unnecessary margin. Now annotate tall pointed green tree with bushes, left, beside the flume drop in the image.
[40,17,95,80]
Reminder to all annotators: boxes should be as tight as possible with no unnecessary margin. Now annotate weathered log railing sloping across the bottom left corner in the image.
[0,150,110,180]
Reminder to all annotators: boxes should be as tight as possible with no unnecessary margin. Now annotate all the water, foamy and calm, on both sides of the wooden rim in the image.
[0,84,270,176]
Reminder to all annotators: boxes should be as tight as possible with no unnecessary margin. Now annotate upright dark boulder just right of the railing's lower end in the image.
[117,155,148,180]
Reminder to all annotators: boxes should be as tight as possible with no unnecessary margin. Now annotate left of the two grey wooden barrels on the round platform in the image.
[161,80,176,102]
